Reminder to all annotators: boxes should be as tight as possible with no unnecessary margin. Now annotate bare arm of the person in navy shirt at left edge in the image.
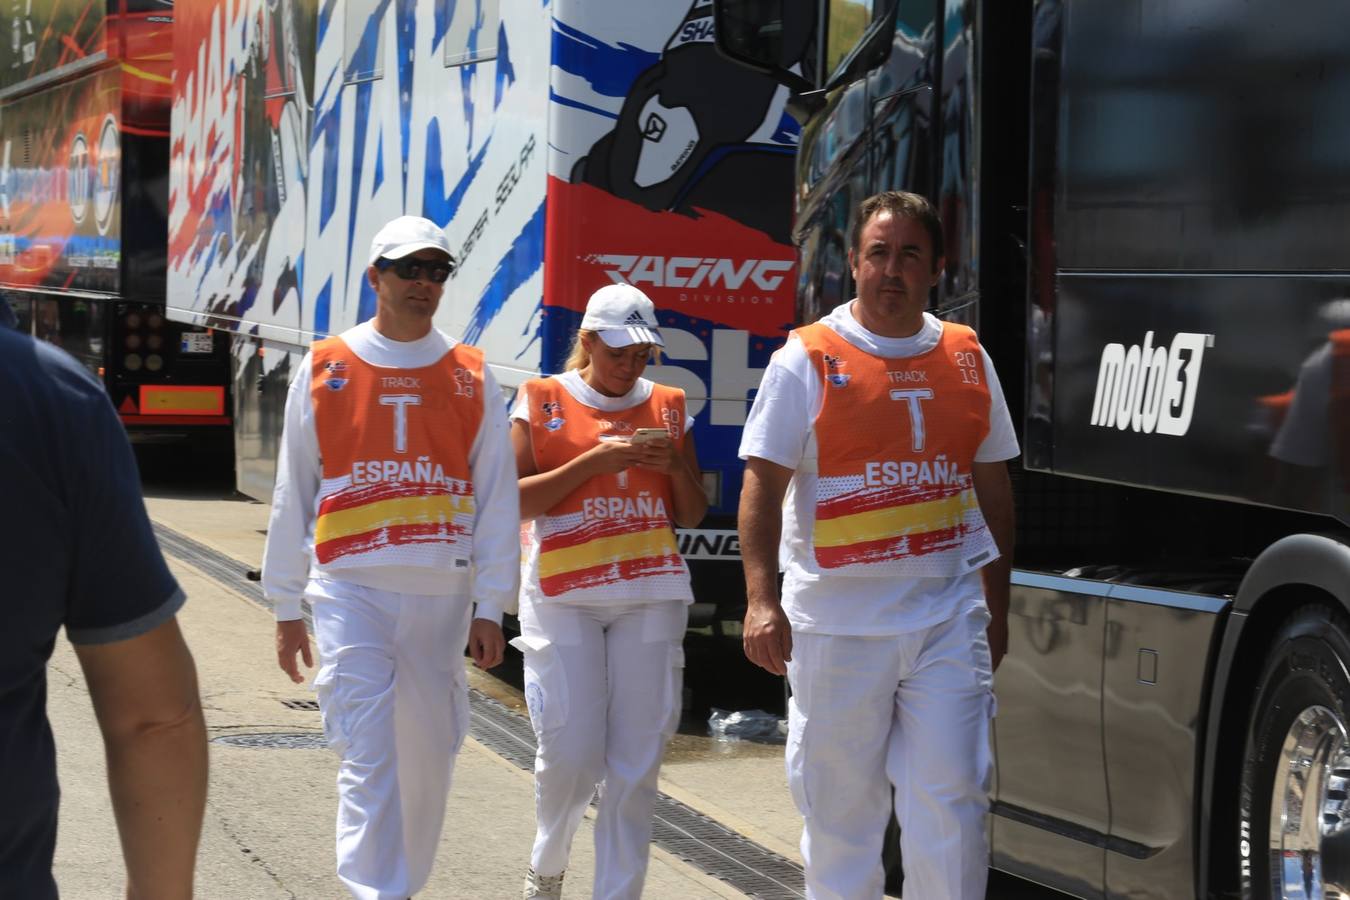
[76,619,207,900]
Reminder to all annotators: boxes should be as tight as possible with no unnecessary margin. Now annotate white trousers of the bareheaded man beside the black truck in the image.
[787,606,994,900]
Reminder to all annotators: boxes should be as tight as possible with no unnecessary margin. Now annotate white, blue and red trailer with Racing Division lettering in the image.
[169,0,798,682]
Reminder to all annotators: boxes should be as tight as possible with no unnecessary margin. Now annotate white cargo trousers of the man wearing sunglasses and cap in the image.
[311,582,471,900]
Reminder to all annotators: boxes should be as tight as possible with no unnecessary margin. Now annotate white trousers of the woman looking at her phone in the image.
[512,599,689,900]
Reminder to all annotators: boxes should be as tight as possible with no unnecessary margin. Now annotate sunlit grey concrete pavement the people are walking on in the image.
[42,447,1061,900]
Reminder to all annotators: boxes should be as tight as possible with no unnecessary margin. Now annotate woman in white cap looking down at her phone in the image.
[512,285,707,900]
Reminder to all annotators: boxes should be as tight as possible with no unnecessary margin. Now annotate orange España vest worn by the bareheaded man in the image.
[795,322,998,578]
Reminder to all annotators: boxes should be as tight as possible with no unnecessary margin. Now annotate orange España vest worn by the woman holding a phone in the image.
[525,378,690,600]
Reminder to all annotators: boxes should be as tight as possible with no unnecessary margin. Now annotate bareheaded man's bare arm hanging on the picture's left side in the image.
[737,456,792,675]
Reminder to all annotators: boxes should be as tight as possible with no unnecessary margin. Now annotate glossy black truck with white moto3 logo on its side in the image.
[717,0,1350,897]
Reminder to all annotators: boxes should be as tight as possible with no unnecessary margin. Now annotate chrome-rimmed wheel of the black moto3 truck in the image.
[1235,606,1350,900]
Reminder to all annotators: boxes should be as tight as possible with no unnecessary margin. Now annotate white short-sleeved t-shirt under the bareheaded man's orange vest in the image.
[740,302,1021,636]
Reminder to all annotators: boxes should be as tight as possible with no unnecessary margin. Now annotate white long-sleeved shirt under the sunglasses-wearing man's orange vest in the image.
[262,321,520,622]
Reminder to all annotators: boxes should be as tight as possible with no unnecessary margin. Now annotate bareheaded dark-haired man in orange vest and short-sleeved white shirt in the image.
[740,192,1018,900]
